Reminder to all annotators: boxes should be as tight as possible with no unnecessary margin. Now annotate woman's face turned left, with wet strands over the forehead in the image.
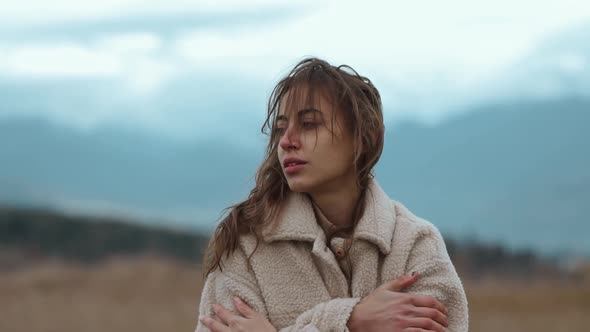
[275,92,356,194]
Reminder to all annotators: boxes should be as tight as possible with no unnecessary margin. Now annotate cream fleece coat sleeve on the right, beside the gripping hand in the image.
[404,220,469,332]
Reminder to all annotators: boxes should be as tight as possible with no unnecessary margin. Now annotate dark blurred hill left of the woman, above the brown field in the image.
[0,207,207,267]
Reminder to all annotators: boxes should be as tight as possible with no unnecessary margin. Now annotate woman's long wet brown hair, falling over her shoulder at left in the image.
[204,58,385,275]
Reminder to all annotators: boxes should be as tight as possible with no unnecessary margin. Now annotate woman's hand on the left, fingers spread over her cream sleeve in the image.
[200,297,276,332]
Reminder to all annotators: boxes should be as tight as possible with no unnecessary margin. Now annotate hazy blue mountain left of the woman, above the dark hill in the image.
[0,118,261,226]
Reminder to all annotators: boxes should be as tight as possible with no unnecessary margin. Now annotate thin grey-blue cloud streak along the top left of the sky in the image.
[0,4,307,43]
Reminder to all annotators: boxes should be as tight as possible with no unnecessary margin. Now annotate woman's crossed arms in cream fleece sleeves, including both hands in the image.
[196,229,468,332]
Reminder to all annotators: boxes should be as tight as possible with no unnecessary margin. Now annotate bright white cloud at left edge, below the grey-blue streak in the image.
[0,33,178,95]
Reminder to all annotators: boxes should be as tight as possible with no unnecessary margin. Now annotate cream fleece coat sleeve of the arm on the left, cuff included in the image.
[195,245,360,332]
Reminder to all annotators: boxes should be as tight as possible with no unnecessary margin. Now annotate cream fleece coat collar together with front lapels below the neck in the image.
[262,180,396,298]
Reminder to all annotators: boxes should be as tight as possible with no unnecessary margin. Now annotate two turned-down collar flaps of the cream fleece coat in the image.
[262,179,396,255]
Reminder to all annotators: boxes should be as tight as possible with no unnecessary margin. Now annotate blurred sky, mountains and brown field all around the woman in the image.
[0,0,590,332]
